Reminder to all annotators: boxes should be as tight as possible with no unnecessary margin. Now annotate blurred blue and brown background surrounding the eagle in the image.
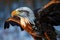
[0,0,60,40]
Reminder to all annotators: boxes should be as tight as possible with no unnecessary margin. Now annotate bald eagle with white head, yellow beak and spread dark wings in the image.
[4,1,60,40]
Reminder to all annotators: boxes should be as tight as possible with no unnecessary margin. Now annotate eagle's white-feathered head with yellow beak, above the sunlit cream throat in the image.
[11,7,35,24]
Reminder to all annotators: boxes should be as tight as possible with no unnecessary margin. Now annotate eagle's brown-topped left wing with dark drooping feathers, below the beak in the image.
[4,16,24,31]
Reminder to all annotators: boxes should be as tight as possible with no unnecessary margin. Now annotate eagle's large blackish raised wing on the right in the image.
[39,3,60,26]
